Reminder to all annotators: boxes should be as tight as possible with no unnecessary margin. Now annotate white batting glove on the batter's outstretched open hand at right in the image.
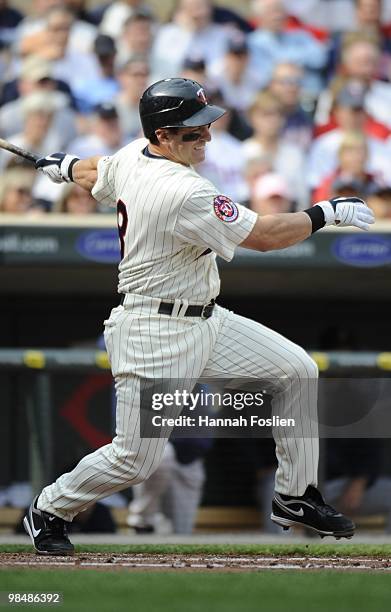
[316,196,375,231]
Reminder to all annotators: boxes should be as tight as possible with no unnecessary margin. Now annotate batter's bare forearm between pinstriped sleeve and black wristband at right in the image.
[240,212,312,251]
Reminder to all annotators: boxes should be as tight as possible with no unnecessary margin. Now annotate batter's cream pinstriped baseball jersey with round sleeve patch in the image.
[92,139,257,304]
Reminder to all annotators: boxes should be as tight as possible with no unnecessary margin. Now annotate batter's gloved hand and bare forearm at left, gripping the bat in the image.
[35,153,101,191]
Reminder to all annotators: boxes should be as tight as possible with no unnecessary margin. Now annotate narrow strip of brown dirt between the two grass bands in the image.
[0,552,391,573]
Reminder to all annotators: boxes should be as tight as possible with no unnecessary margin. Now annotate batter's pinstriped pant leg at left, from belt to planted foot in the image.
[38,306,219,521]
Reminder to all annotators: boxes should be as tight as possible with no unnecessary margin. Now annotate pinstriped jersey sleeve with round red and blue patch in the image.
[174,181,258,261]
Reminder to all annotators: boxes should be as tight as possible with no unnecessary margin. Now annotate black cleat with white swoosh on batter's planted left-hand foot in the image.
[23,495,75,556]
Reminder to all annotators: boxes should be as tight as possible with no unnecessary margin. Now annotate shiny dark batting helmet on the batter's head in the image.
[140,78,226,138]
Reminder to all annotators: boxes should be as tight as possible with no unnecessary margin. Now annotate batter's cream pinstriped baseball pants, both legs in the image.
[37,295,319,521]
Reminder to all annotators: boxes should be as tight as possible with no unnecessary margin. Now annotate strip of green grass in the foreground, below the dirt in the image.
[0,569,391,612]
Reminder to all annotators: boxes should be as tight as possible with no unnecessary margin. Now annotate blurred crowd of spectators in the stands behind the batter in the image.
[0,0,391,218]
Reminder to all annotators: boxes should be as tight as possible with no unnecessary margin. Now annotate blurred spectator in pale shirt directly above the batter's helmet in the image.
[152,0,233,80]
